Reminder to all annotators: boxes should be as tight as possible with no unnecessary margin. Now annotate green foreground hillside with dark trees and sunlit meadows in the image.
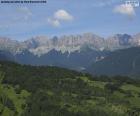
[0,61,140,116]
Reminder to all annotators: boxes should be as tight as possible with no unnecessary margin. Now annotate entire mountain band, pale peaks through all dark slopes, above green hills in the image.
[0,33,140,75]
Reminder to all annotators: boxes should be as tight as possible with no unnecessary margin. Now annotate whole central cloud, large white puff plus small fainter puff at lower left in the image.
[47,9,74,27]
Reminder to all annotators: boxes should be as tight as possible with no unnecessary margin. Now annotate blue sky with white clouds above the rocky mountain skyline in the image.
[0,0,140,40]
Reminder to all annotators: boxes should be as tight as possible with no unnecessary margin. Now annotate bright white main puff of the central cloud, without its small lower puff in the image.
[54,9,73,21]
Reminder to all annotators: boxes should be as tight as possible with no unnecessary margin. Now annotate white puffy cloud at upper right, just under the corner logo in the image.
[114,4,136,17]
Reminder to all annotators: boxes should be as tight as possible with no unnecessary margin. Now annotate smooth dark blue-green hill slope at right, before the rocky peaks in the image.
[88,47,140,75]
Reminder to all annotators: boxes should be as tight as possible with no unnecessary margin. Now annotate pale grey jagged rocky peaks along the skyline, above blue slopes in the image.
[0,33,140,56]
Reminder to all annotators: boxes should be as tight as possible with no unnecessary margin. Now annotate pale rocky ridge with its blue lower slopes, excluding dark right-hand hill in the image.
[0,33,140,73]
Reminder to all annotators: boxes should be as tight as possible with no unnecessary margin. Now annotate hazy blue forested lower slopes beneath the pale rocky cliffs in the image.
[0,48,109,71]
